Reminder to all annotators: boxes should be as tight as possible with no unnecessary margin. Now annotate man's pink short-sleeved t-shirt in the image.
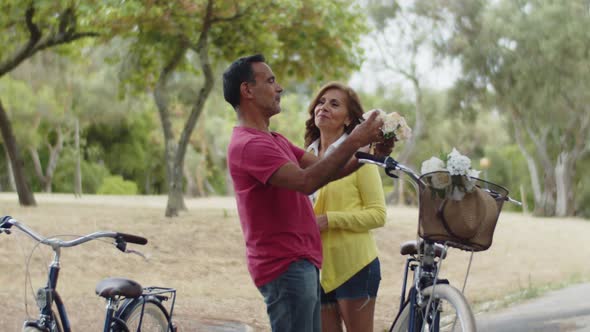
[227,127,322,287]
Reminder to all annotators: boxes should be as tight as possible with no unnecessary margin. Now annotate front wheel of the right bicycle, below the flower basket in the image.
[390,284,475,332]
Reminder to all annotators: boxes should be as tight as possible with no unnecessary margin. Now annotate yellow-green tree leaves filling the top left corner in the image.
[0,0,141,70]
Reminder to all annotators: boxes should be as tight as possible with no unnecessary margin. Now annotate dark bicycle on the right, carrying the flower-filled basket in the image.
[356,152,520,332]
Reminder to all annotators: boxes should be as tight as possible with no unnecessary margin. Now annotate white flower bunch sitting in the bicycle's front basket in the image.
[421,148,480,201]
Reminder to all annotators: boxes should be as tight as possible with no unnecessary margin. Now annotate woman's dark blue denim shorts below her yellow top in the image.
[320,258,381,304]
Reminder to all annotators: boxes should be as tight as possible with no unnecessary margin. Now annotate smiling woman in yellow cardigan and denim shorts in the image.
[305,82,393,332]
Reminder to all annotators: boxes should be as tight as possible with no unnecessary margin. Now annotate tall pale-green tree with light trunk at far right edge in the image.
[427,0,590,216]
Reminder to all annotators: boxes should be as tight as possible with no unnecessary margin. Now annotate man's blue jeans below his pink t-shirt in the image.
[258,260,321,332]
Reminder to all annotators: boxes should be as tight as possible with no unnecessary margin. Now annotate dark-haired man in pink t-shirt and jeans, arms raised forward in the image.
[223,55,392,332]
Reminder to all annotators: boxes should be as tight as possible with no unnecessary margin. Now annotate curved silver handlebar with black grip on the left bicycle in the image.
[0,216,148,251]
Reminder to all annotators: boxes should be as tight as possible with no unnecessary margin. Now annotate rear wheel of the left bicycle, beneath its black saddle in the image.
[121,298,169,332]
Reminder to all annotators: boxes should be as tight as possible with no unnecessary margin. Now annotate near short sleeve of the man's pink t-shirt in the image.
[241,138,294,183]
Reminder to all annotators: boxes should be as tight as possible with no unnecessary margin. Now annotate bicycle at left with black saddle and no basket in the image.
[0,216,176,332]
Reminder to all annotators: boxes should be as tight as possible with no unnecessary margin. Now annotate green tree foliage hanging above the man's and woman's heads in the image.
[121,0,366,92]
